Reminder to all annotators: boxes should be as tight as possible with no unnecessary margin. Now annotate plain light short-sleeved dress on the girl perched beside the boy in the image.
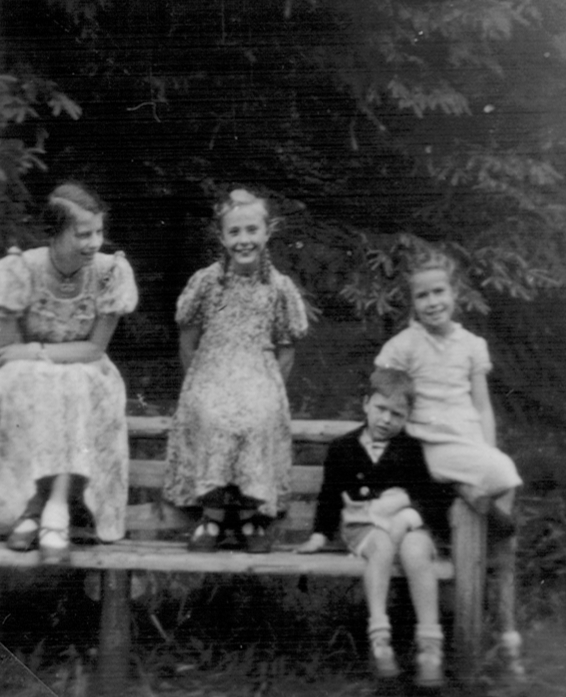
[375,321,521,496]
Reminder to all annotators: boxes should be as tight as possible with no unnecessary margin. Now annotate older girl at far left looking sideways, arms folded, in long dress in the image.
[0,183,137,562]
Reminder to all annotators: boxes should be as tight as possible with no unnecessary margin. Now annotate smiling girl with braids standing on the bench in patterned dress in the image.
[164,189,307,552]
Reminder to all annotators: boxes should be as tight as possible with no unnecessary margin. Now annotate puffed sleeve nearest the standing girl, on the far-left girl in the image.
[96,252,138,315]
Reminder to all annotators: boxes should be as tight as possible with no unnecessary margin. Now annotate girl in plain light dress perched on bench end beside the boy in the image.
[375,249,521,535]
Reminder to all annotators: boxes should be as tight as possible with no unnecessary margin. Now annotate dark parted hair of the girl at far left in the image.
[43,181,108,237]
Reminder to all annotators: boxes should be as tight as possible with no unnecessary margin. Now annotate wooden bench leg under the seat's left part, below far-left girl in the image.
[94,569,130,697]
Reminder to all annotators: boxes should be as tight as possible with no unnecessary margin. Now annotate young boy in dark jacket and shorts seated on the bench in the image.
[297,368,454,687]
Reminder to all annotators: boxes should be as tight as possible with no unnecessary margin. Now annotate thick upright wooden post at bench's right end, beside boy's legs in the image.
[452,499,487,678]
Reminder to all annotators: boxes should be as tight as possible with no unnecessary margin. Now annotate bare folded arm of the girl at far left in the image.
[0,315,120,365]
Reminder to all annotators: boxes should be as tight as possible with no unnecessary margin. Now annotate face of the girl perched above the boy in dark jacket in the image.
[411,269,456,336]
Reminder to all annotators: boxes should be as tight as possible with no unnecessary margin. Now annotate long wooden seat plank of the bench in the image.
[0,540,454,580]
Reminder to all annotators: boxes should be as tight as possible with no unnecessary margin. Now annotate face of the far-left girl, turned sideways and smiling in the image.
[53,206,104,268]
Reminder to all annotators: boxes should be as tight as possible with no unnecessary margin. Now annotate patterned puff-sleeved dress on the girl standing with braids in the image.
[164,263,307,516]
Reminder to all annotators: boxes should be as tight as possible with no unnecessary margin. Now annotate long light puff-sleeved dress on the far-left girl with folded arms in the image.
[0,247,138,541]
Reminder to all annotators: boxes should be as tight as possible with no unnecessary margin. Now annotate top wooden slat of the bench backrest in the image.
[128,416,361,443]
